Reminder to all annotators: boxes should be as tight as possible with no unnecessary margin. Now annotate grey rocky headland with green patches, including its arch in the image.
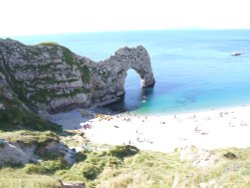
[0,39,155,112]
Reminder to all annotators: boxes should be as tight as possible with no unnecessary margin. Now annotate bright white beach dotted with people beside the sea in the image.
[49,106,250,152]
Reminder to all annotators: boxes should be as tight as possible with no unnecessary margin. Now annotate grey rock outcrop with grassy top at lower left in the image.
[0,131,75,166]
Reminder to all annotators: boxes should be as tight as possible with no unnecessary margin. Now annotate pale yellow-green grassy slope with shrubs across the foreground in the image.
[0,131,250,188]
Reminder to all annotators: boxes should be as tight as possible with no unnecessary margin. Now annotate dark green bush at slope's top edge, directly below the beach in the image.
[109,145,139,159]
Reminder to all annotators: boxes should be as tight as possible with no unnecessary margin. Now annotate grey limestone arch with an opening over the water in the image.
[92,46,155,106]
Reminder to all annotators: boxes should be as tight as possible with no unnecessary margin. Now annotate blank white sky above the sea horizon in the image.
[0,0,250,37]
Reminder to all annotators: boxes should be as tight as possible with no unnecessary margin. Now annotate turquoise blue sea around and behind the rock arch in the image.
[13,30,250,113]
